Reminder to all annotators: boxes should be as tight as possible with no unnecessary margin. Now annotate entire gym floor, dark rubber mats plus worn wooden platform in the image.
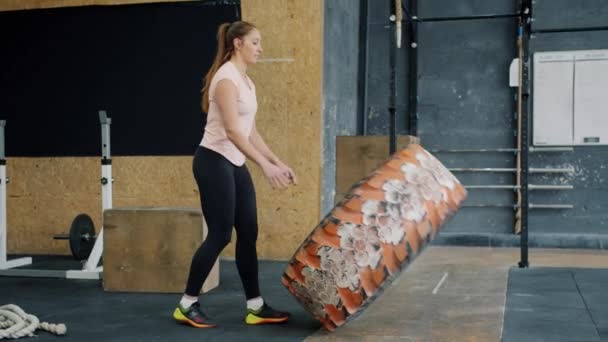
[0,246,608,342]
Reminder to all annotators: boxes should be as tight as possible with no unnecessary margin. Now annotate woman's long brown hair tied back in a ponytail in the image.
[201,21,255,113]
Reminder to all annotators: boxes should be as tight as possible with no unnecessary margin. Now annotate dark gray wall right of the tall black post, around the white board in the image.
[530,0,608,240]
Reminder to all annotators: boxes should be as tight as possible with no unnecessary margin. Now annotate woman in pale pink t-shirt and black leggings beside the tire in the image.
[173,21,297,328]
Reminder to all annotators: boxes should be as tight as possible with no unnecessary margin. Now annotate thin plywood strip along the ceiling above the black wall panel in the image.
[0,0,187,11]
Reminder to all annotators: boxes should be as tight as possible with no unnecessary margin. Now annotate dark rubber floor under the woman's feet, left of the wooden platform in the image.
[0,257,321,342]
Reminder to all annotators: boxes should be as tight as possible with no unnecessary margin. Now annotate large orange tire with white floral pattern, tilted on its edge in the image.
[282,144,467,331]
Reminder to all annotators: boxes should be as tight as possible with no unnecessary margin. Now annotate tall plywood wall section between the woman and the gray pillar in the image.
[241,0,323,259]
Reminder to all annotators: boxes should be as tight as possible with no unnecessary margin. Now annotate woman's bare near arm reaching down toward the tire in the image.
[215,80,289,187]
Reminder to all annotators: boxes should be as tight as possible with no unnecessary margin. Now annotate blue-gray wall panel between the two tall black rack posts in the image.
[418,0,517,234]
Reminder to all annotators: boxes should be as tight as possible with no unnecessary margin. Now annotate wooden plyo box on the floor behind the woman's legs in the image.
[103,207,219,293]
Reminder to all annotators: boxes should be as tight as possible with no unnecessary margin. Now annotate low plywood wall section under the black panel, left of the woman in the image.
[7,157,199,254]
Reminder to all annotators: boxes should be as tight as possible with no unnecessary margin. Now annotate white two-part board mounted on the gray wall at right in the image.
[532,50,608,146]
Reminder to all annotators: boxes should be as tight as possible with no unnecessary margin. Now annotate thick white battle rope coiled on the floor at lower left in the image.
[0,304,67,340]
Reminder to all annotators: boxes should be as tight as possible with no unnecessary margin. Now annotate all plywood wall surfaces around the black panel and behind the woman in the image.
[0,0,323,260]
